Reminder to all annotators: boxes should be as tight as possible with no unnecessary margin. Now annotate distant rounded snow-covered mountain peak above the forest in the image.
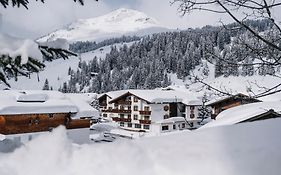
[38,8,168,42]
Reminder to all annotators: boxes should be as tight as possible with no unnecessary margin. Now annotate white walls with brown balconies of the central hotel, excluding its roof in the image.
[98,95,192,131]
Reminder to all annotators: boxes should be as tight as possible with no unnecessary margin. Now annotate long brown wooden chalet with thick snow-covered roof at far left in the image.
[0,90,99,142]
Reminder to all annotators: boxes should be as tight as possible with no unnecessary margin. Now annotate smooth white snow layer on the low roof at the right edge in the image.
[201,101,281,128]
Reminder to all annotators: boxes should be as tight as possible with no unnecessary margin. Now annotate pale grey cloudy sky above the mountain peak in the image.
[0,0,268,38]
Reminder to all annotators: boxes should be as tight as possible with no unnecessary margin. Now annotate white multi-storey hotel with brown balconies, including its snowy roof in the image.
[99,89,200,132]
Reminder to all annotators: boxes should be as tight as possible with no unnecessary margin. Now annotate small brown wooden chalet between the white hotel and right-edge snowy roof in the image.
[206,93,261,119]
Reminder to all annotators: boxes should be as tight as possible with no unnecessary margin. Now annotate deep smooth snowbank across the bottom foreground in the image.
[0,119,281,175]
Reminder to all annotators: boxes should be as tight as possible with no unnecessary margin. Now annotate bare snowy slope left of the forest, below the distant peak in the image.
[0,42,134,90]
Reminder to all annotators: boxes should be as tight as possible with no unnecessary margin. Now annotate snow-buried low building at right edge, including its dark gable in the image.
[202,101,281,128]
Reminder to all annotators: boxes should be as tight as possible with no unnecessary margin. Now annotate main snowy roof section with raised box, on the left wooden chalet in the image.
[0,90,78,115]
